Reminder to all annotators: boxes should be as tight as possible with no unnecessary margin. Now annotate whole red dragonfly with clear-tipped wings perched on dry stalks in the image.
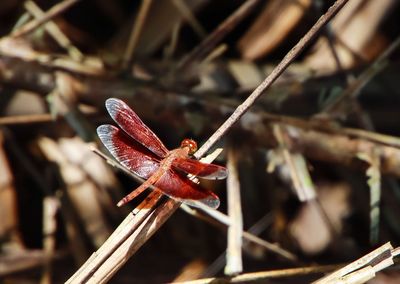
[97,98,227,208]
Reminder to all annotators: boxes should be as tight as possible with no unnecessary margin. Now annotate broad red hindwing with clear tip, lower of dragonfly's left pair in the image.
[97,124,160,179]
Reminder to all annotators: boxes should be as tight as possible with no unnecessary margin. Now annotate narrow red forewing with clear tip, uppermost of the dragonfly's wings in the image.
[106,98,168,158]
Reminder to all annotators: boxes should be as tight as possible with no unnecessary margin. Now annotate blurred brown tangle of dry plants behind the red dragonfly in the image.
[0,0,400,283]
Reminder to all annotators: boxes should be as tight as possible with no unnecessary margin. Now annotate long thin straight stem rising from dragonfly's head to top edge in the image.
[195,0,348,157]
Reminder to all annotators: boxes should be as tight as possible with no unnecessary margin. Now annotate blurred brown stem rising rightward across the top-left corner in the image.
[11,0,81,37]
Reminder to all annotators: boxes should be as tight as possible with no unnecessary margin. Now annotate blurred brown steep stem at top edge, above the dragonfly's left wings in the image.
[123,0,153,68]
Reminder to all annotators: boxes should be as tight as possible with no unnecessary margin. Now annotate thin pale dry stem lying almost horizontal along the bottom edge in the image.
[175,265,338,284]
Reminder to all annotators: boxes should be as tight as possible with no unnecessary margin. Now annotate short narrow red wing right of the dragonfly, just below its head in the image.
[172,158,228,179]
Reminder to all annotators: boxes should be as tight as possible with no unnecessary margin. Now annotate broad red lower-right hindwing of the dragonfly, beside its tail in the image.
[154,170,220,209]
